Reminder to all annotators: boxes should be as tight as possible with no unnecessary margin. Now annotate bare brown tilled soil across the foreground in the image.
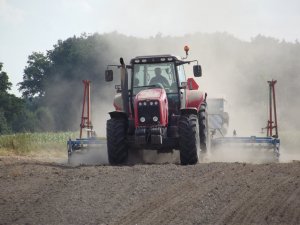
[0,157,300,224]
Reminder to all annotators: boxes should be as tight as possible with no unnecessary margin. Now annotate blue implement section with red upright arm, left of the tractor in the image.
[67,80,106,163]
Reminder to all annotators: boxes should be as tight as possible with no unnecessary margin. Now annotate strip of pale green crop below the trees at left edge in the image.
[0,132,79,155]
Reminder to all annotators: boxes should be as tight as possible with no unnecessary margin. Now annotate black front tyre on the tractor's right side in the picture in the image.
[178,114,200,165]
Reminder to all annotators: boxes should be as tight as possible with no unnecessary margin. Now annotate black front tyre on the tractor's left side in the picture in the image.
[106,119,128,165]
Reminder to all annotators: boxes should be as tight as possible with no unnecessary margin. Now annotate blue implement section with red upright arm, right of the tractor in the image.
[211,80,280,160]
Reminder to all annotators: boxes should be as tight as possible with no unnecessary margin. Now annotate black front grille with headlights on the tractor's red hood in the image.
[137,100,160,126]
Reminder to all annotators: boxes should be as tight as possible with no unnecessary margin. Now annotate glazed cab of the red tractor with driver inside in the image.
[130,55,186,115]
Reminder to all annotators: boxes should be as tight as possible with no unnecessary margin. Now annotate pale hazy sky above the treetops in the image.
[0,0,300,96]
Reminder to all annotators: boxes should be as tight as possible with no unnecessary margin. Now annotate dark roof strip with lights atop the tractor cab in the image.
[130,55,183,64]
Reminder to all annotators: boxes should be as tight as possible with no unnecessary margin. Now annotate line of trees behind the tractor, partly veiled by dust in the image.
[0,32,300,134]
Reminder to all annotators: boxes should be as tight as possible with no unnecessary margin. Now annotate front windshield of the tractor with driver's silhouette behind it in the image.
[133,63,178,95]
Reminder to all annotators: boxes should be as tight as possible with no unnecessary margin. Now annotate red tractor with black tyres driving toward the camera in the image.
[105,46,209,165]
